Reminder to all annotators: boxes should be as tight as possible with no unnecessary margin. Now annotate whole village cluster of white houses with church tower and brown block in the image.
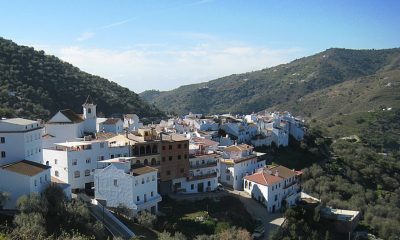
[0,97,304,216]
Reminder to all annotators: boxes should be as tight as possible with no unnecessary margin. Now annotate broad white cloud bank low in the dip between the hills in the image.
[39,38,304,92]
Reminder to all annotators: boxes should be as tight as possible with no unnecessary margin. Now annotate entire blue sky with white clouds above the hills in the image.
[0,0,400,92]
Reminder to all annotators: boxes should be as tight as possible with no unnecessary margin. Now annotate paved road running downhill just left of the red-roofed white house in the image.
[228,190,285,239]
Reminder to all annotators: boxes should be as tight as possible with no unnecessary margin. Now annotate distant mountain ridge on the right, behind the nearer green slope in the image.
[139,48,400,114]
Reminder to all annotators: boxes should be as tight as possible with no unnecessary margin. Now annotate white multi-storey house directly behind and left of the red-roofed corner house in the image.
[220,144,265,190]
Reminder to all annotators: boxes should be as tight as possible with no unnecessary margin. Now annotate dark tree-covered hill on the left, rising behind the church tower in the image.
[0,38,163,119]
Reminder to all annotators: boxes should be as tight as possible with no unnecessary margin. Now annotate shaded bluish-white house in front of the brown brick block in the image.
[94,158,161,216]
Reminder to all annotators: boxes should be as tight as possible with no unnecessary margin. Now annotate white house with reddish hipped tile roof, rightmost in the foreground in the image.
[244,166,302,212]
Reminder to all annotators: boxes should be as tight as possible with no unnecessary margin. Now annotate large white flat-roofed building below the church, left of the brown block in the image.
[43,140,129,190]
